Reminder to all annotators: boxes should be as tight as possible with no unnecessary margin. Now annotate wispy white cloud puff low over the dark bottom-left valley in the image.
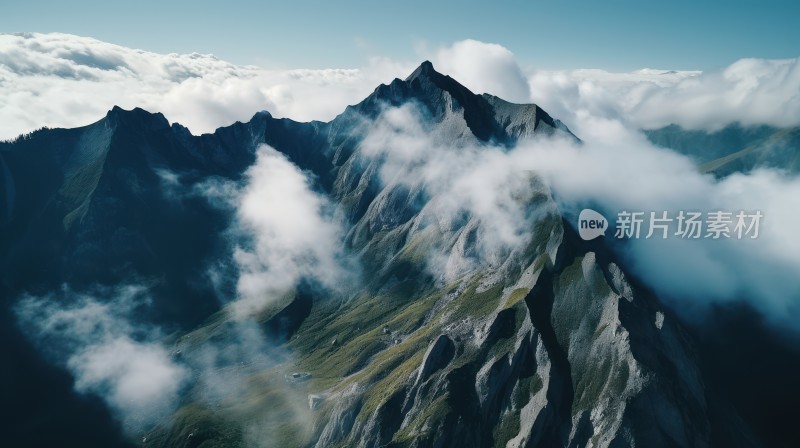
[14,286,189,433]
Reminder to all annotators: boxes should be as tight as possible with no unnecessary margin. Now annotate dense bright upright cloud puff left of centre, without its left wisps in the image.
[234,145,344,313]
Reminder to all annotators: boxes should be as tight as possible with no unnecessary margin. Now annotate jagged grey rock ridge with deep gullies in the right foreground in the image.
[304,178,736,447]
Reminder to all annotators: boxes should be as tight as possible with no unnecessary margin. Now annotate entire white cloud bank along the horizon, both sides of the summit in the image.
[0,33,800,139]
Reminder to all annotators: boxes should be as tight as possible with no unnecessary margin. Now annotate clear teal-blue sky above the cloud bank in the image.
[0,0,800,70]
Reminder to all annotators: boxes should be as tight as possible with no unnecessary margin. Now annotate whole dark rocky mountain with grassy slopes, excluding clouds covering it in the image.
[0,62,757,447]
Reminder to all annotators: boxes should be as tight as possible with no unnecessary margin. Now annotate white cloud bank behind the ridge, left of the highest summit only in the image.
[0,33,413,139]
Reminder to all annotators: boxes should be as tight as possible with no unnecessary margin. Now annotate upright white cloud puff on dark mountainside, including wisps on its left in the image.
[189,144,358,319]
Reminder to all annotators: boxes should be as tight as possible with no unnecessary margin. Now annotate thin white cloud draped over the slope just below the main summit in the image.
[360,104,555,281]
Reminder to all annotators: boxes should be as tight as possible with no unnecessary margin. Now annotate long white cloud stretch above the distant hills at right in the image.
[530,58,800,134]
